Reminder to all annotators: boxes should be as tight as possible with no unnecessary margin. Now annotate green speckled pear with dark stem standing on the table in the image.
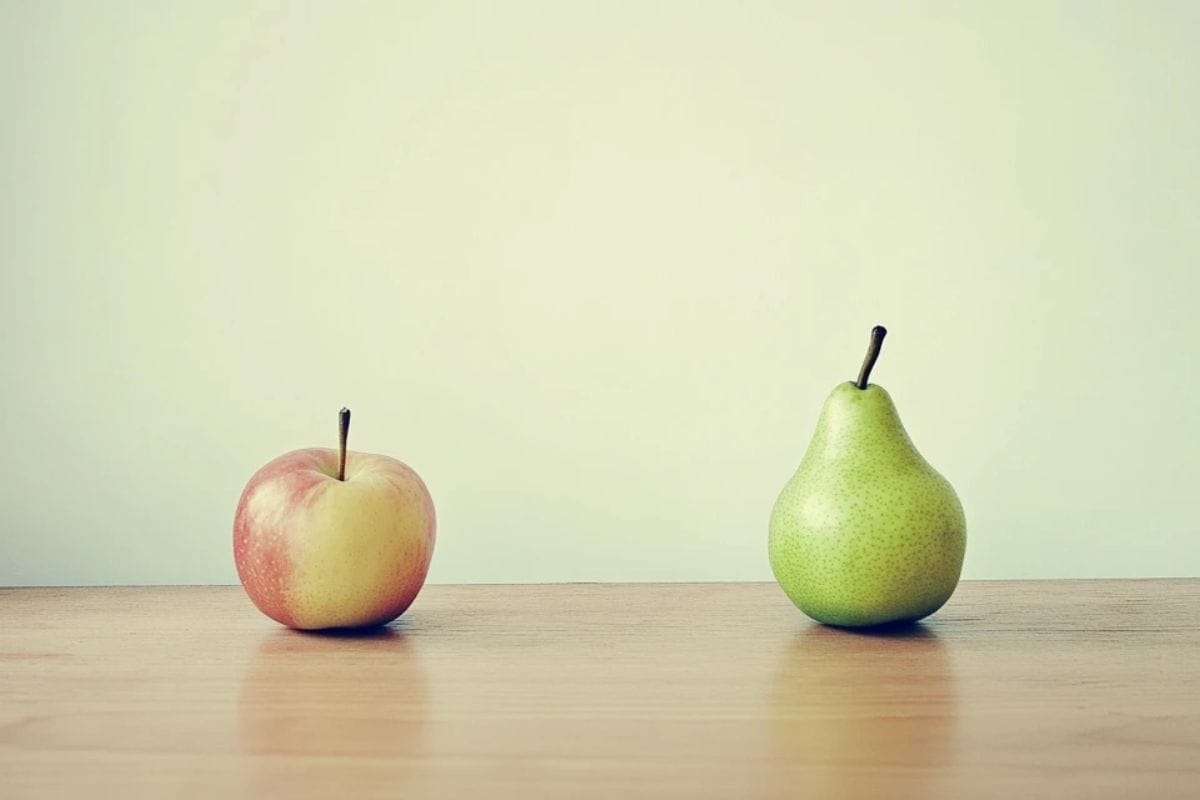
[769,325,966,627]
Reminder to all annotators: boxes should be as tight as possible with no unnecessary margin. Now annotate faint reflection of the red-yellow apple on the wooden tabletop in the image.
[238,626,427,796]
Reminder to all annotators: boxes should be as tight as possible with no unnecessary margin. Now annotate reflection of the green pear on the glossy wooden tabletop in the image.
[767,625,958,798]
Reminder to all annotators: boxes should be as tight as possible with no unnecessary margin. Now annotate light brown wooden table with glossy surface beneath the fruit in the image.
[0,581,1200,800]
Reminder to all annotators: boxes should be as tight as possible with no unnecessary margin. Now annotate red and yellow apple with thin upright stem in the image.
[233,408,437,630]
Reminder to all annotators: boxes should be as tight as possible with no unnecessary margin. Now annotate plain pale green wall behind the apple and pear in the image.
[0,0,1200,584]
